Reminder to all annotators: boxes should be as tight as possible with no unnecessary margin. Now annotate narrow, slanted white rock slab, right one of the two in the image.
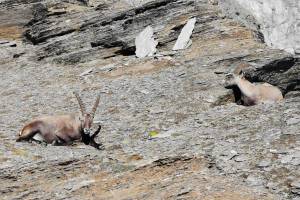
[173,17,196,50]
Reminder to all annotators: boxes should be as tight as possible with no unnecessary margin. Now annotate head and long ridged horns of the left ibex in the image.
[73,92,100,136]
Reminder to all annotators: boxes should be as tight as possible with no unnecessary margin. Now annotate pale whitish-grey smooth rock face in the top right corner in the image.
[220,0,300,54]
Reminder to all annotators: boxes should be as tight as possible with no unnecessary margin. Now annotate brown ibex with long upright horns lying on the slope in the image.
[16,92,101,149]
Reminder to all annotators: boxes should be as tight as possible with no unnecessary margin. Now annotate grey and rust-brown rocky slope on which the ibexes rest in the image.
[0,0,300,200]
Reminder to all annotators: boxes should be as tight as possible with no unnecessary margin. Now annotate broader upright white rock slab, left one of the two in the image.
[135,26,158,58]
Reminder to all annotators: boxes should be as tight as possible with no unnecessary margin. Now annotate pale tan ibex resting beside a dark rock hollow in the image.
[226,66,283,106]
